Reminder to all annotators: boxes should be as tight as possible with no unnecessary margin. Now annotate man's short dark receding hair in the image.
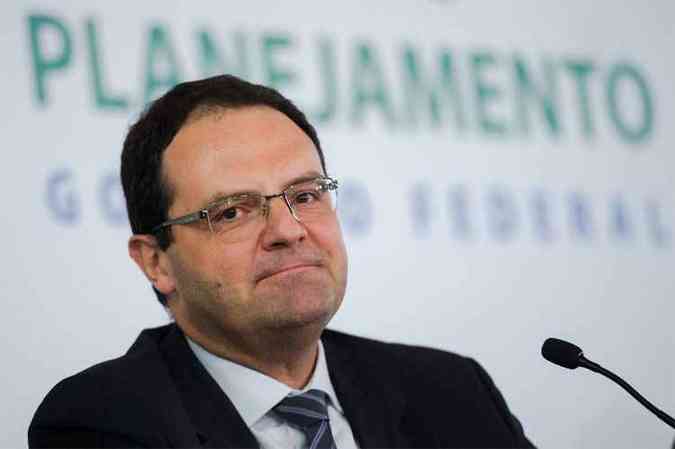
[120,75,326,306]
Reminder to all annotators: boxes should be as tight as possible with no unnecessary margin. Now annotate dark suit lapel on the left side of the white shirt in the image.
[161,324,258,448]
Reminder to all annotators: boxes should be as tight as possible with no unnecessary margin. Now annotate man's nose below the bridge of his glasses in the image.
[263,196,307,250]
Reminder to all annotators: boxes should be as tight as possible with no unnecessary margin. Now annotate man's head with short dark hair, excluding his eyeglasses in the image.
[122,76,347,354]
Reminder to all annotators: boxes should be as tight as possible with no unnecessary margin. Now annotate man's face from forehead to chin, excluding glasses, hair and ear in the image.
[163,107,347,345]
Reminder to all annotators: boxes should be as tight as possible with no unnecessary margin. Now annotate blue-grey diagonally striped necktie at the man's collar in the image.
[274,390,335,449]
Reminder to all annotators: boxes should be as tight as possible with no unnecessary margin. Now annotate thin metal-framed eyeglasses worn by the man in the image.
[152,176,338,241]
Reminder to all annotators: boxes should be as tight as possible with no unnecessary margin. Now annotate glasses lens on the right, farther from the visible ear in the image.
[286,179,337,220]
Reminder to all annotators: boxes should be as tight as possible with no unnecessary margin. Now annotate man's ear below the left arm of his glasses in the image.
[129,234,176,296]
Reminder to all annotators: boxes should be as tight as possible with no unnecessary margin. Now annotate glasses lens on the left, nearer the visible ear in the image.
[208,193,263,237]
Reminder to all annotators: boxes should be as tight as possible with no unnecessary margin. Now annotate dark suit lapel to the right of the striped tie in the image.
[322,331,410,448]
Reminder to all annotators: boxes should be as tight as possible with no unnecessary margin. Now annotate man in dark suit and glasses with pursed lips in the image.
[29,76,531,449]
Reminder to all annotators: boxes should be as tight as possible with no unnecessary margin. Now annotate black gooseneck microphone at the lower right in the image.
[541,338,675,429]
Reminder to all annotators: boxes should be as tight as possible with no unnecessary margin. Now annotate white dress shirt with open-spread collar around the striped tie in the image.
[186,337,357,449]
